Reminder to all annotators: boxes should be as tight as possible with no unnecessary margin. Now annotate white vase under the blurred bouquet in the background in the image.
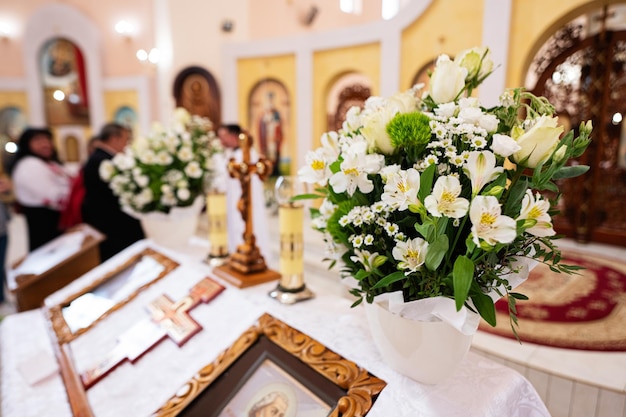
[138,200,202,249]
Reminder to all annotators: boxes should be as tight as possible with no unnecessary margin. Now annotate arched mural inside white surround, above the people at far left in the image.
[40,38,89,126]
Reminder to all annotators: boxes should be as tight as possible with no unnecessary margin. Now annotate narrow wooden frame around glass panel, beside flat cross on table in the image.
[45,248,179,344]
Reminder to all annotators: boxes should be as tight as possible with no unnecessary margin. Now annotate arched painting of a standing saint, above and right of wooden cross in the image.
[248,79,292,177]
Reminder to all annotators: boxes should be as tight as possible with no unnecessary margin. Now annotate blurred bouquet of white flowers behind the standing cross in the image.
[100,108,223,213]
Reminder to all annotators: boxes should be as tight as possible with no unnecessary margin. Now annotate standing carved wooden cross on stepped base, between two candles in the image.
[213,133,280,288]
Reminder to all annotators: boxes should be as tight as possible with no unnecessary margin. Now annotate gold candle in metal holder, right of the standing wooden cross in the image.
[269,176,314,304]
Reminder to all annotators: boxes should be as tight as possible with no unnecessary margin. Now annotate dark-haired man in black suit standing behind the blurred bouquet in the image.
[82,123,144,261]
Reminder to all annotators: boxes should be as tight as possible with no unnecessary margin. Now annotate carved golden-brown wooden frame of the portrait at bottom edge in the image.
[153,313,386,417]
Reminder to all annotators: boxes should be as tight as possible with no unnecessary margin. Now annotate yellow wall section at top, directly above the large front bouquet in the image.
[400,0,488,90]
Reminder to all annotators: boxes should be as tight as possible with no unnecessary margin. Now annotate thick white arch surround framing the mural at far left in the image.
[23,3,105,130]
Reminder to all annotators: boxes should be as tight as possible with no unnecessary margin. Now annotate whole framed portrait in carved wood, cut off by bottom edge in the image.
[153,314,386,417]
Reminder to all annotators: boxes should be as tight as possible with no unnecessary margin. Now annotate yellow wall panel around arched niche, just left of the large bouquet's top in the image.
[311,43,380,148]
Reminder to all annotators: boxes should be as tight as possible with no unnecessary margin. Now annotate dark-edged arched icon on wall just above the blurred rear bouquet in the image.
[174,67,222,128]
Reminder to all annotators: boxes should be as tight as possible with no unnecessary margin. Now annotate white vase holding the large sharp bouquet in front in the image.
[364,302,473,385]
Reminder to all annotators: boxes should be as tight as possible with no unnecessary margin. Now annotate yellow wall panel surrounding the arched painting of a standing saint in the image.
[237,55,298,173]
